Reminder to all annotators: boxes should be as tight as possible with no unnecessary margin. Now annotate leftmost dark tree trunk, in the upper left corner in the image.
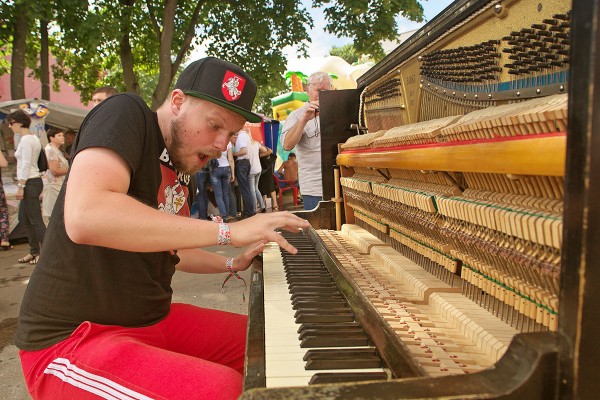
[10,9,28,100]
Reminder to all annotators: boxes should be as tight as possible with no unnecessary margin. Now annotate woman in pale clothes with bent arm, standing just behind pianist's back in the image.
[42,128,69,226]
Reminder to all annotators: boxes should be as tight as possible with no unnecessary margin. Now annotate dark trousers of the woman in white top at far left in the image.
[19,178,46,256]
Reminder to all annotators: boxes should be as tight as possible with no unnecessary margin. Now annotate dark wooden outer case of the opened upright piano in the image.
[241,0,600,400]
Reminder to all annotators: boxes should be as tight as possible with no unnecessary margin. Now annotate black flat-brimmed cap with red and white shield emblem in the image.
[175,57,262,122]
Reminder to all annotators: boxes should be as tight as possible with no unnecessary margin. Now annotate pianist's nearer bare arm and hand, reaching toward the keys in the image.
[65,147,309,252]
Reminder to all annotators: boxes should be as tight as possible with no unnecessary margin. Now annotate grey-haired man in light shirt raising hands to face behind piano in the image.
[280,72,333,210]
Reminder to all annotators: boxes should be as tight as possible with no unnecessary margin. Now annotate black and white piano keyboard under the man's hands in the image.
[263,233,387,387]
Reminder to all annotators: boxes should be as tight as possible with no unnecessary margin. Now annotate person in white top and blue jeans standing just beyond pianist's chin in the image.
[231,130,256,218]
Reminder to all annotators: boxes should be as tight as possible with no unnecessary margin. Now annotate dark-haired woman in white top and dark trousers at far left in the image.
[6,109,46,264]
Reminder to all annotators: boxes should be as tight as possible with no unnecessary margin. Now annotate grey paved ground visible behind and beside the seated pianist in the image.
[0,176,300,400]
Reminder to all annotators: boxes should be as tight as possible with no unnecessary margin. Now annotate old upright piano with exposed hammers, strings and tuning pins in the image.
[241,0,600,400]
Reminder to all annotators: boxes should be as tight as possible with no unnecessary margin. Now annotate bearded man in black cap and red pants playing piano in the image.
[16,58,308,399]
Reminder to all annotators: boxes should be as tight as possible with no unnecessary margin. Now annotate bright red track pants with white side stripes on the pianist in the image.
[19,304,246,400]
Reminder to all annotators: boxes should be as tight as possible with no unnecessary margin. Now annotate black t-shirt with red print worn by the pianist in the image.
[15,93,190,350]
